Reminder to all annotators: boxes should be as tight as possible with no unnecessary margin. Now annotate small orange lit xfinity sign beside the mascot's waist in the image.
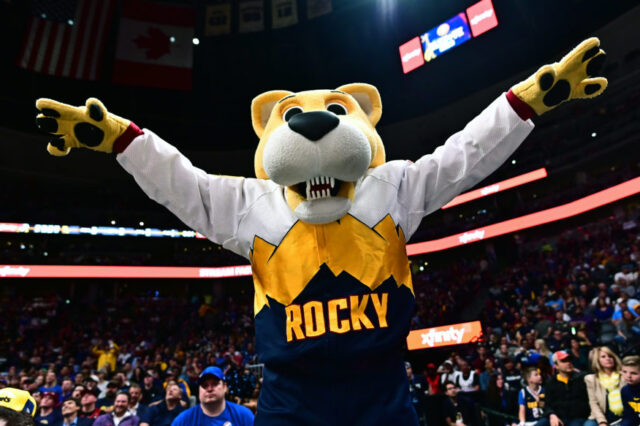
[407,321,482,351]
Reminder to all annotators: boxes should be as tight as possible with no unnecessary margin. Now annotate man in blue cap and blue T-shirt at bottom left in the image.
[171,367,254,426]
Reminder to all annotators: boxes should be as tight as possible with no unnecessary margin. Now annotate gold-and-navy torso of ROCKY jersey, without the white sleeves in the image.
[251,215,414,365]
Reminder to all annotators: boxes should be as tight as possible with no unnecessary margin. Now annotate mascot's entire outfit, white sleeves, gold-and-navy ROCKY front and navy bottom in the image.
[118,95,533,425]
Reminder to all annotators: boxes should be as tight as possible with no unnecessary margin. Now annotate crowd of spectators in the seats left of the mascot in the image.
[0,295,260,425]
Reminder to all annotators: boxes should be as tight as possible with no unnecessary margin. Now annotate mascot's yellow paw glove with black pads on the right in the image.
[511,37,607,115]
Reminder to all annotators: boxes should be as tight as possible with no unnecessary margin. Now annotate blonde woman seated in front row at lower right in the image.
[584,346,626,426]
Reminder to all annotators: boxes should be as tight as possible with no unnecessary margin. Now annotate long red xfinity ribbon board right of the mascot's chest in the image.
[407,177,640,256]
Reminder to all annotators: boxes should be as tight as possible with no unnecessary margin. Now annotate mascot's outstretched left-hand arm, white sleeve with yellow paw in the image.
[36,98,275,255]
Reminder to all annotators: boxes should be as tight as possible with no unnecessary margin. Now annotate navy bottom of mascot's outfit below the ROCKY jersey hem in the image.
[255,356,418,426]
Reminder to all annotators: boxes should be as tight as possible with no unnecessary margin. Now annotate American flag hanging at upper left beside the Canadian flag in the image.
[18,0,115,80]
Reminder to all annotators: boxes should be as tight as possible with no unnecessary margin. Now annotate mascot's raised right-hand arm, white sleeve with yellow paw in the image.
[392,38,607,234]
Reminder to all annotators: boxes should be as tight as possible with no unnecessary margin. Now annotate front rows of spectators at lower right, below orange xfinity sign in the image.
[406,345,640,426]
